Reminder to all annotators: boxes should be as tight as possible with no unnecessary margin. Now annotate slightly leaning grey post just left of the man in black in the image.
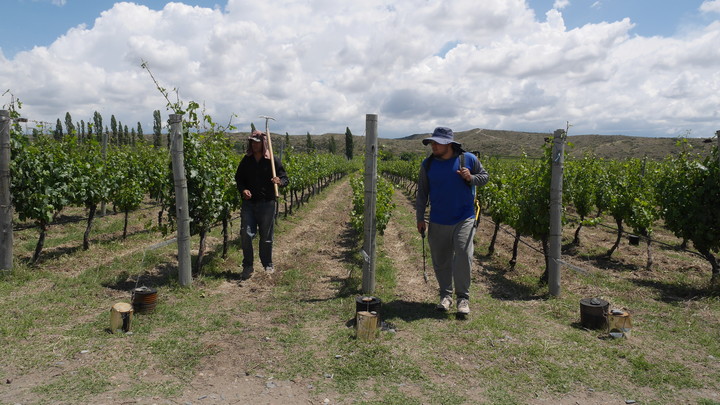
[170,114,192,286]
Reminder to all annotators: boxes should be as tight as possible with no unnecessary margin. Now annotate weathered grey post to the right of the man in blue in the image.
[548,129,567,297]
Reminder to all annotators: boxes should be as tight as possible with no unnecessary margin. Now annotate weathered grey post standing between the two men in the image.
[363,114,377,295]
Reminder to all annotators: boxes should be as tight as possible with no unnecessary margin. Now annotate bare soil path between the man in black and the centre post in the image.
[169,180,354,404]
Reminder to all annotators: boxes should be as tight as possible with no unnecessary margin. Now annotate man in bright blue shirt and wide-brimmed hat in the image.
[415,127,488,315]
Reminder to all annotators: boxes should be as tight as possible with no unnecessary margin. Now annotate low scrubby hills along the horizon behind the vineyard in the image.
[231,128,717,160]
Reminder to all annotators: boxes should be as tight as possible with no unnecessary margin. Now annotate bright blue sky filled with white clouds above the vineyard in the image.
[0,0,720,138]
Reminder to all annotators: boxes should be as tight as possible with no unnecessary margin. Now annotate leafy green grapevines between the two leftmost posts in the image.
[11,137,163,263]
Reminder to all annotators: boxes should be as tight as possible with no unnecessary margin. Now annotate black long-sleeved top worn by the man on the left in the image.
[235,155,289,201]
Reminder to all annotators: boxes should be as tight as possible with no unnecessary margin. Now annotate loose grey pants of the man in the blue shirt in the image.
[428,218,475,299]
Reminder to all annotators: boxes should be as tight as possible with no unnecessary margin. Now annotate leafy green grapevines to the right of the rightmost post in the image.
[567,139,720,282]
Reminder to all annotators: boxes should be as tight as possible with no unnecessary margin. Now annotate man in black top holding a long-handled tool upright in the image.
[235,131,288,280]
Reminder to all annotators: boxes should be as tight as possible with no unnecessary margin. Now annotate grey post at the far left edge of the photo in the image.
[0,110,13,270]
